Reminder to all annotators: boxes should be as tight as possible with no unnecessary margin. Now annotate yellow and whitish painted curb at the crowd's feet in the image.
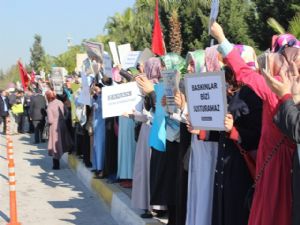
[62,154,163,225]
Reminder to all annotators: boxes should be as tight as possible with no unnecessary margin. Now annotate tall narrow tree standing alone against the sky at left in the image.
[30,34,45,72]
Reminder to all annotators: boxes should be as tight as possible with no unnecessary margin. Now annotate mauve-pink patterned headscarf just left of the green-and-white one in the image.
[144,57,161,83]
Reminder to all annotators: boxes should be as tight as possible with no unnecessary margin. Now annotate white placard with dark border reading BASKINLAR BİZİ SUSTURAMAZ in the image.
[184,72,227,131]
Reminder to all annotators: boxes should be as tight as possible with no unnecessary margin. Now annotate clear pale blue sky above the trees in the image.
[0,0,135,72]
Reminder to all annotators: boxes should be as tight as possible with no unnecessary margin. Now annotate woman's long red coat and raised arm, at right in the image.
[211,22,300,225]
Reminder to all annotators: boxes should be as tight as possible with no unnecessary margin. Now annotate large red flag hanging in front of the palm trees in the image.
[152,0,166,56]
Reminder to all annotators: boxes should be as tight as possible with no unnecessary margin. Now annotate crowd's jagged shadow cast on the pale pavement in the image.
[24,145,109,225]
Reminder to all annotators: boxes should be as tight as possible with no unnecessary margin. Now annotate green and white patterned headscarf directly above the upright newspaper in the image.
[161,52,186,74]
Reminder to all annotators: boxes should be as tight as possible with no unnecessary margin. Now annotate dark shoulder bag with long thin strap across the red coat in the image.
[245,136,287,211]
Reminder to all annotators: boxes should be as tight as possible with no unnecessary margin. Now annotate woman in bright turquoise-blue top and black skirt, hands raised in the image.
[136,59,167,216]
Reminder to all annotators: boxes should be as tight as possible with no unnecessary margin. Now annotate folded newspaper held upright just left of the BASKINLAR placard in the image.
[161,70,180,113]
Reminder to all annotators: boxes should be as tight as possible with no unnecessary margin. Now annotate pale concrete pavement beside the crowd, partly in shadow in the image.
[0,134,117,225]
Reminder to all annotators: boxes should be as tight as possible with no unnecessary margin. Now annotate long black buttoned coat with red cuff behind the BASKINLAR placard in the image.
[211,86,262,225]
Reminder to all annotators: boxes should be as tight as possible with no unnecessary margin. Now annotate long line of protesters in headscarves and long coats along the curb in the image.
[0,23,300,225]
